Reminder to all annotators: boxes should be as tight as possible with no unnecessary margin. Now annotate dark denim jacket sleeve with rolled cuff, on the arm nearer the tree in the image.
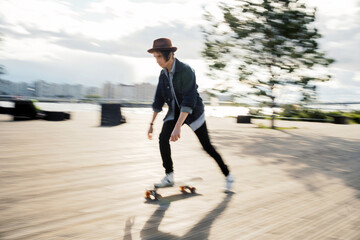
[180,66,198,114]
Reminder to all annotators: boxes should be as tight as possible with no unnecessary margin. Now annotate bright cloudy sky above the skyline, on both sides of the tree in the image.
[0,0,360,102]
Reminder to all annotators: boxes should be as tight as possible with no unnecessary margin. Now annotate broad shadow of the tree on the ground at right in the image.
[211,130,360,198]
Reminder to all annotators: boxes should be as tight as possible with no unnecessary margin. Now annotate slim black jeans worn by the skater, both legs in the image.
[159,120,229,176]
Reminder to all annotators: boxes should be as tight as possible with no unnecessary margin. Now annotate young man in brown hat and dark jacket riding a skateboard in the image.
[148,38,234,191]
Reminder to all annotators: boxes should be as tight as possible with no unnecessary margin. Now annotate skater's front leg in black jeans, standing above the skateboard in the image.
[159,120,176,174]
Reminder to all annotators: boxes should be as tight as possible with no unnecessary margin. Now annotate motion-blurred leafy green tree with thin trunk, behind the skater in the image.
[202,0,334,128]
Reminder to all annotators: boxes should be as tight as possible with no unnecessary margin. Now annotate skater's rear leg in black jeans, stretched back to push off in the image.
[195,122,229,176]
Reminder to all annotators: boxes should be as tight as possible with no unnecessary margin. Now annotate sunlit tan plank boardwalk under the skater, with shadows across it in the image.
[0,112,360,240]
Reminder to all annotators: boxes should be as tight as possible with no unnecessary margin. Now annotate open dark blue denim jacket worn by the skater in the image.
[152,58,204,124]
